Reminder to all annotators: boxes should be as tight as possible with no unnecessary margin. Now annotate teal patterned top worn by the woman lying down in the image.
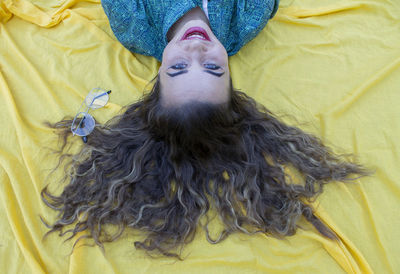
[101,0,279,61]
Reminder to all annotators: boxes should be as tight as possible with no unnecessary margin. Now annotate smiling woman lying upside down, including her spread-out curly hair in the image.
[42,1,369,257]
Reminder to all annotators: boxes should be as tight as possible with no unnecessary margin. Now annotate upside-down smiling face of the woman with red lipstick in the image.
[159,20,230,106]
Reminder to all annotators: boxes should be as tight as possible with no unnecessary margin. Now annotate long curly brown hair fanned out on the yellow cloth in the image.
[42,75,371,258]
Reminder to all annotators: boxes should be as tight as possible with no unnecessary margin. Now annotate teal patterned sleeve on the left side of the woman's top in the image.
[101,0,164,60]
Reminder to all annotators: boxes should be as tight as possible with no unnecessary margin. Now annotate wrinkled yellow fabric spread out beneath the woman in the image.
[0,0,400,273]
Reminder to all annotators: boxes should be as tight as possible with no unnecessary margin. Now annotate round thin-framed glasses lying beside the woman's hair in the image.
[71,88,111,143]
